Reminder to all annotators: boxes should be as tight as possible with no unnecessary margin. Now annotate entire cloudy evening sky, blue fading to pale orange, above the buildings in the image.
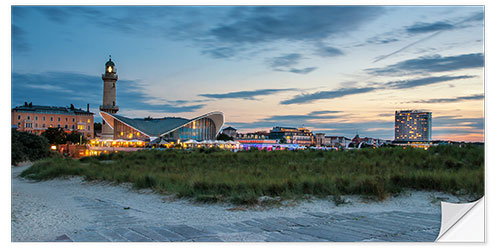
[11,6,484,141]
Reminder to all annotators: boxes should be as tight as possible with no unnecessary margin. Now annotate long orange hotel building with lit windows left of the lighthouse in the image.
[11,103,94,138]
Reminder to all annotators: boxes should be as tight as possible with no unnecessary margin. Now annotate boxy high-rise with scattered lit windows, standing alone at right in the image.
[394,110,432,142]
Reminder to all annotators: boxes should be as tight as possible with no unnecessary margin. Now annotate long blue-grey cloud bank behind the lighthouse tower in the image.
[12,72,205,113]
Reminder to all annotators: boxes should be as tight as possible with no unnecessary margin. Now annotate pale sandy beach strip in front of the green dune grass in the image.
[12,162,468,241]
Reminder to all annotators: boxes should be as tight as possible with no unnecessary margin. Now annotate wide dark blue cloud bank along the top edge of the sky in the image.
[32,6,384,58]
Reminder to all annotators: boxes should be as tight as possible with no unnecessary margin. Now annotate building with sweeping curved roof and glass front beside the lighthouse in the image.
[99,111,224,141]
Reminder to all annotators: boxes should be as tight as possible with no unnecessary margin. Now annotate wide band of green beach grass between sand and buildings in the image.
[21,145,484,205]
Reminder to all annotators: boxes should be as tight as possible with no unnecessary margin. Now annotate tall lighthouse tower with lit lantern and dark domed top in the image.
[99,56,119,139]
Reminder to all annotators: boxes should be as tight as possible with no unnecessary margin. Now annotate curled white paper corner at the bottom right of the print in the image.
[436,196,484,242]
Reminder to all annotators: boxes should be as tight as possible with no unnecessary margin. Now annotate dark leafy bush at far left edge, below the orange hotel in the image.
[11,129,50,165]
